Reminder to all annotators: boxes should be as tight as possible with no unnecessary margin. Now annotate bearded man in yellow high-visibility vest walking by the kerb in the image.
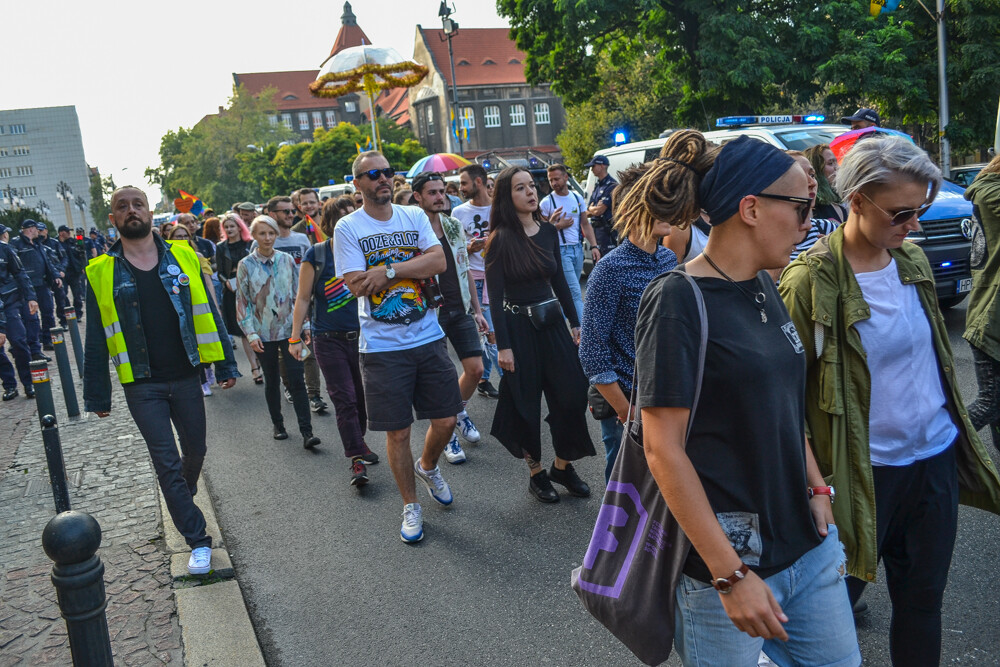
[83,186,239,574]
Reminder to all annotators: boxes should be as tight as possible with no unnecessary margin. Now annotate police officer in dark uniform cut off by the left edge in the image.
[0,225,38,401]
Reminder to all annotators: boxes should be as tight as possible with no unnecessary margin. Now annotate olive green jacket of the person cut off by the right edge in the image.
[963,174,1000,361]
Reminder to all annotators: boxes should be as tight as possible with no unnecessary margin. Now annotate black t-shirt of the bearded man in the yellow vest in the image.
[126,260,201,382]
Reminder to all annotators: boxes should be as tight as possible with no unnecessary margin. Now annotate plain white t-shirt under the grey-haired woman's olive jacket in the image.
[854,259,958,466]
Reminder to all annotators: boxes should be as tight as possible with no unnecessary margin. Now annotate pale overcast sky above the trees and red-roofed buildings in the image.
[0,0,507,204]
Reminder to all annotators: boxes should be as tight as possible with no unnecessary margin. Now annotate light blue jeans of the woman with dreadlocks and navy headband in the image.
[674,525,861,667]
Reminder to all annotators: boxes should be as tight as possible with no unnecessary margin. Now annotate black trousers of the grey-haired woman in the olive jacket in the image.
[845,444,958,667]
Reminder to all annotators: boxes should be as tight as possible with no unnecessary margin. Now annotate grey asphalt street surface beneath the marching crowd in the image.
[199,304,1000,667]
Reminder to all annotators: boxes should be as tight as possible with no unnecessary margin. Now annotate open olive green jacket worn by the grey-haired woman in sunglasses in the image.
[778,226,1000,581]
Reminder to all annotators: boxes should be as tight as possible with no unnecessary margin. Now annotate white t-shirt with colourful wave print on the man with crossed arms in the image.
[333,206,444,352]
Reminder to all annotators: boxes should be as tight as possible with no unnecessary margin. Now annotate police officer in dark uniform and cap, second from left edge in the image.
[10,218,62,354]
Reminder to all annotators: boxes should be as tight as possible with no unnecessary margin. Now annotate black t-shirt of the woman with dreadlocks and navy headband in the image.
[635,273,820,582]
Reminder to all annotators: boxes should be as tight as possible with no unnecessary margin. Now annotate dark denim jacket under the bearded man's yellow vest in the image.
[83,234,240,412]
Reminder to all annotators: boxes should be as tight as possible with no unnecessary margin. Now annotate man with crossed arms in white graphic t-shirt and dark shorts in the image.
[333,151,462,542]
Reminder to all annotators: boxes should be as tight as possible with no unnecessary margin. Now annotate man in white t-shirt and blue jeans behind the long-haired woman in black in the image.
[538,164,601,321]
